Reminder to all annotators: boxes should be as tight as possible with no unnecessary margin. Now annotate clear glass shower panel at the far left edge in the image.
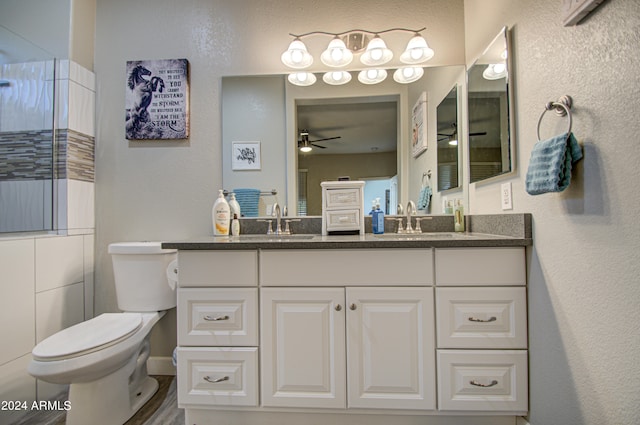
[0,25,56,233]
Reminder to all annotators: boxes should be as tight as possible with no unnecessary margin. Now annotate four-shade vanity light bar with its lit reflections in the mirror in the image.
[281,28,434,86]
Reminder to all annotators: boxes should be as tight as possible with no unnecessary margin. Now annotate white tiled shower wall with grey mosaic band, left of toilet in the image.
[0,60,95,423]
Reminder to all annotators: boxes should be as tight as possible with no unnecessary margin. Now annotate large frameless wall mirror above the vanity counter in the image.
[221,65,465,219]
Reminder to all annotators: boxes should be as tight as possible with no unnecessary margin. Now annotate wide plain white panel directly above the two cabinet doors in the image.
[260,248,433,287]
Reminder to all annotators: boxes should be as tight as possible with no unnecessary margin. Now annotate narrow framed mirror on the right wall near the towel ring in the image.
[467,28,515,183]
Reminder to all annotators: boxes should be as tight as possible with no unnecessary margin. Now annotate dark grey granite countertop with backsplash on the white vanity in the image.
[162,214,532,251]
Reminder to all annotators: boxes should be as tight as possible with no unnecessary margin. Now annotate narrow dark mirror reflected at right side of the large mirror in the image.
[436,86,459,191]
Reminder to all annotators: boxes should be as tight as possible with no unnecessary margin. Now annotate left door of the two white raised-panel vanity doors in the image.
[260,288,346,408]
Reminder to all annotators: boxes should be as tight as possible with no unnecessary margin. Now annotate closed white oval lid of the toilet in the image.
[31,313,142,360]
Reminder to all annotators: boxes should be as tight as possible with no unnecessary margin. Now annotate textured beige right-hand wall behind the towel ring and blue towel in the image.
[465,0,640,425]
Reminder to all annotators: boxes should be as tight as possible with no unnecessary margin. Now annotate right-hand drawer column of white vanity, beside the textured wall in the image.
[435,247,528,413]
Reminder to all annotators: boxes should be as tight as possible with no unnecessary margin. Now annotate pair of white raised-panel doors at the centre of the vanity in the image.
[260,287,435,410]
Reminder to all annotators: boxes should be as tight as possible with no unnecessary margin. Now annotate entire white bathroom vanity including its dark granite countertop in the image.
[163,215,531,425]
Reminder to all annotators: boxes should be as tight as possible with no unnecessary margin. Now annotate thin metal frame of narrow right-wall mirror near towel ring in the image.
[465,26,517,184]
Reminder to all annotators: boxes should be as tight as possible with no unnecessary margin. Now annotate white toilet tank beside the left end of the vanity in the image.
[109,242,178,312]
